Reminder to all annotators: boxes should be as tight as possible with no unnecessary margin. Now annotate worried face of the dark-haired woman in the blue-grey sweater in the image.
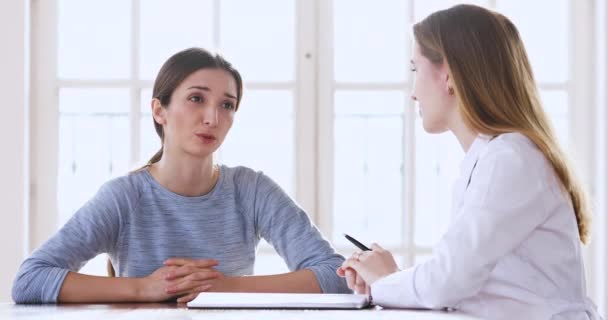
[152,69,237,157]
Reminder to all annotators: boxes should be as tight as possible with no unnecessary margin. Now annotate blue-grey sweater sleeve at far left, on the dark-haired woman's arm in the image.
[12,177,133,303]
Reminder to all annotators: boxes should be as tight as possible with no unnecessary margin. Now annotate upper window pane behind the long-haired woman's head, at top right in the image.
[496,0,570,83]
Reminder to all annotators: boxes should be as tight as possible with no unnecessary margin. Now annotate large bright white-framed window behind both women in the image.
[33,0,584,273]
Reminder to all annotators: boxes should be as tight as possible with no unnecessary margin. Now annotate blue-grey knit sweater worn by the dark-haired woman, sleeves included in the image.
[12,166,350,303]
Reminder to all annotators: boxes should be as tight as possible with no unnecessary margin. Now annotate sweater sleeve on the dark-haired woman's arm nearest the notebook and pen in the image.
[254,173,351,293]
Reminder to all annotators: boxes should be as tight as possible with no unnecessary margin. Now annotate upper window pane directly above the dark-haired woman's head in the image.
[139,0,214,79]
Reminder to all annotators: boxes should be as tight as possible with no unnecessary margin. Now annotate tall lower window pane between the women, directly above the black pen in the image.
[333,91,405,245]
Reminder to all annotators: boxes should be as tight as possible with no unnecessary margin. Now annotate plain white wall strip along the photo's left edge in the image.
[0,0,29,302]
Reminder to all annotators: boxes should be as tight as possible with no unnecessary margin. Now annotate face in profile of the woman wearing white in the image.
[411,43,456,133]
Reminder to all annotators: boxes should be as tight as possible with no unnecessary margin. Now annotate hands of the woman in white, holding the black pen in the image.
[337,243,399,293]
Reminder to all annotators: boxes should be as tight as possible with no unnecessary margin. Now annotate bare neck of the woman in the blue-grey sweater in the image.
[149,149,219,197]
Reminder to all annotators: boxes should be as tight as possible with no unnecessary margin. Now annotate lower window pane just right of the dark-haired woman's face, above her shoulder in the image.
[219,90,295,197]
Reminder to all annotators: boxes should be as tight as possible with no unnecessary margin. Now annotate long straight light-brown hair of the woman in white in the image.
[414,5,590,243]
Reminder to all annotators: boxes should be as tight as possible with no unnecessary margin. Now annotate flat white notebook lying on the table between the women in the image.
[188,292,370,309]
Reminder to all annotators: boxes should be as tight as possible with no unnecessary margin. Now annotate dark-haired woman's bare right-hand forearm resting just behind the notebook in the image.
[217,269,321,293]
